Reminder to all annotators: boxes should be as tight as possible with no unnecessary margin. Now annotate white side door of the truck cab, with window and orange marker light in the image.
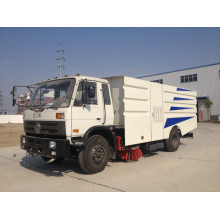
[71,80,103,136]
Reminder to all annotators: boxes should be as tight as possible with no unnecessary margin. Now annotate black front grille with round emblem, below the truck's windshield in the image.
[24,121,66,136]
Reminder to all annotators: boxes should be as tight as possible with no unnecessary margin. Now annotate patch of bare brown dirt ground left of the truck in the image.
[0,124,24,147]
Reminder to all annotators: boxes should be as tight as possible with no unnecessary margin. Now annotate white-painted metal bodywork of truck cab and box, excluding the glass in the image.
[24,76,197,146]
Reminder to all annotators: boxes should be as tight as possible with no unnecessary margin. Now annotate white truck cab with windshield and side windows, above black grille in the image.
[24,76,114,140]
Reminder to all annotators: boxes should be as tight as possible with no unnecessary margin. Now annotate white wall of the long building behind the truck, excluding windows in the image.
[140,64,220,115]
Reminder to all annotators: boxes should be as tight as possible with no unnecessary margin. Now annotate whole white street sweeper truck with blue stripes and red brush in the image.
[12,75,197,174]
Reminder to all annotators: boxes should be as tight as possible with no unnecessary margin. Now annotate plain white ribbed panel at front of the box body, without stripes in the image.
[123,77,151,146]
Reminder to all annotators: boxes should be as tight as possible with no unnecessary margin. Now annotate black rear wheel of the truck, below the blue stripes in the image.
[164,127,180,152]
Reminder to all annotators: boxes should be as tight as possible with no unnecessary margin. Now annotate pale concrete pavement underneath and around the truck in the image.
[0,123,220,192]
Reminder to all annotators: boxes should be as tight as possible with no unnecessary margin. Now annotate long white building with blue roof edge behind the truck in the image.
[138,63,220,121]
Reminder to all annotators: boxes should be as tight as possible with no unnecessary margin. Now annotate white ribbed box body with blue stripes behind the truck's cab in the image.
[107,76,197,146]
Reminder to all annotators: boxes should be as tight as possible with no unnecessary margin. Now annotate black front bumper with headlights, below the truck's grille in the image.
[21,135,70,158]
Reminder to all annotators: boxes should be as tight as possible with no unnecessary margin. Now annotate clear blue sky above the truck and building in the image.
[0,27,220,113]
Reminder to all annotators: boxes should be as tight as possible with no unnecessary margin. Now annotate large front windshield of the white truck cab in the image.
[29,79,76,108]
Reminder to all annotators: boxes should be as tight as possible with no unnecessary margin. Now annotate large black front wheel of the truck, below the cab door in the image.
[78,135,110,174]
